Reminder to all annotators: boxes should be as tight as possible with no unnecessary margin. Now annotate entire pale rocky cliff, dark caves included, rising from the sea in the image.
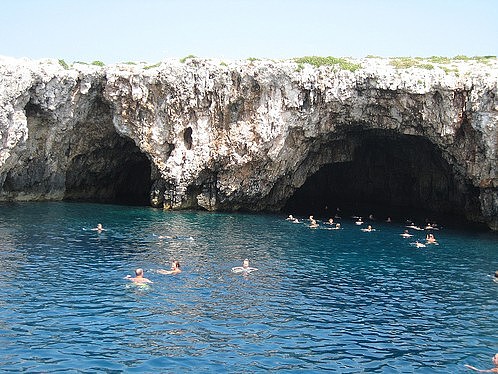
[0,57,498,229]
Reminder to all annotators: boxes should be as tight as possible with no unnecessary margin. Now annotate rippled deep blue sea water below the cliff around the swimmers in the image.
[0,203,498,373]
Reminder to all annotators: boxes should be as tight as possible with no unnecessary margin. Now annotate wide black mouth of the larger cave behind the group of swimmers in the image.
[283,130,479,225]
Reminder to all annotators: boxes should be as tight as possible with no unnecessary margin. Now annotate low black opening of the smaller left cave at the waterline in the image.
[64,134,152,205]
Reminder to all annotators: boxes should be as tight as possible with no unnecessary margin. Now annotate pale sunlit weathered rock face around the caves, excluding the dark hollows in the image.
[0,58,498,227]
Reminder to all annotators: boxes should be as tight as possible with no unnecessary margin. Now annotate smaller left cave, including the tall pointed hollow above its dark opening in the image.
[64,97,152,205]
